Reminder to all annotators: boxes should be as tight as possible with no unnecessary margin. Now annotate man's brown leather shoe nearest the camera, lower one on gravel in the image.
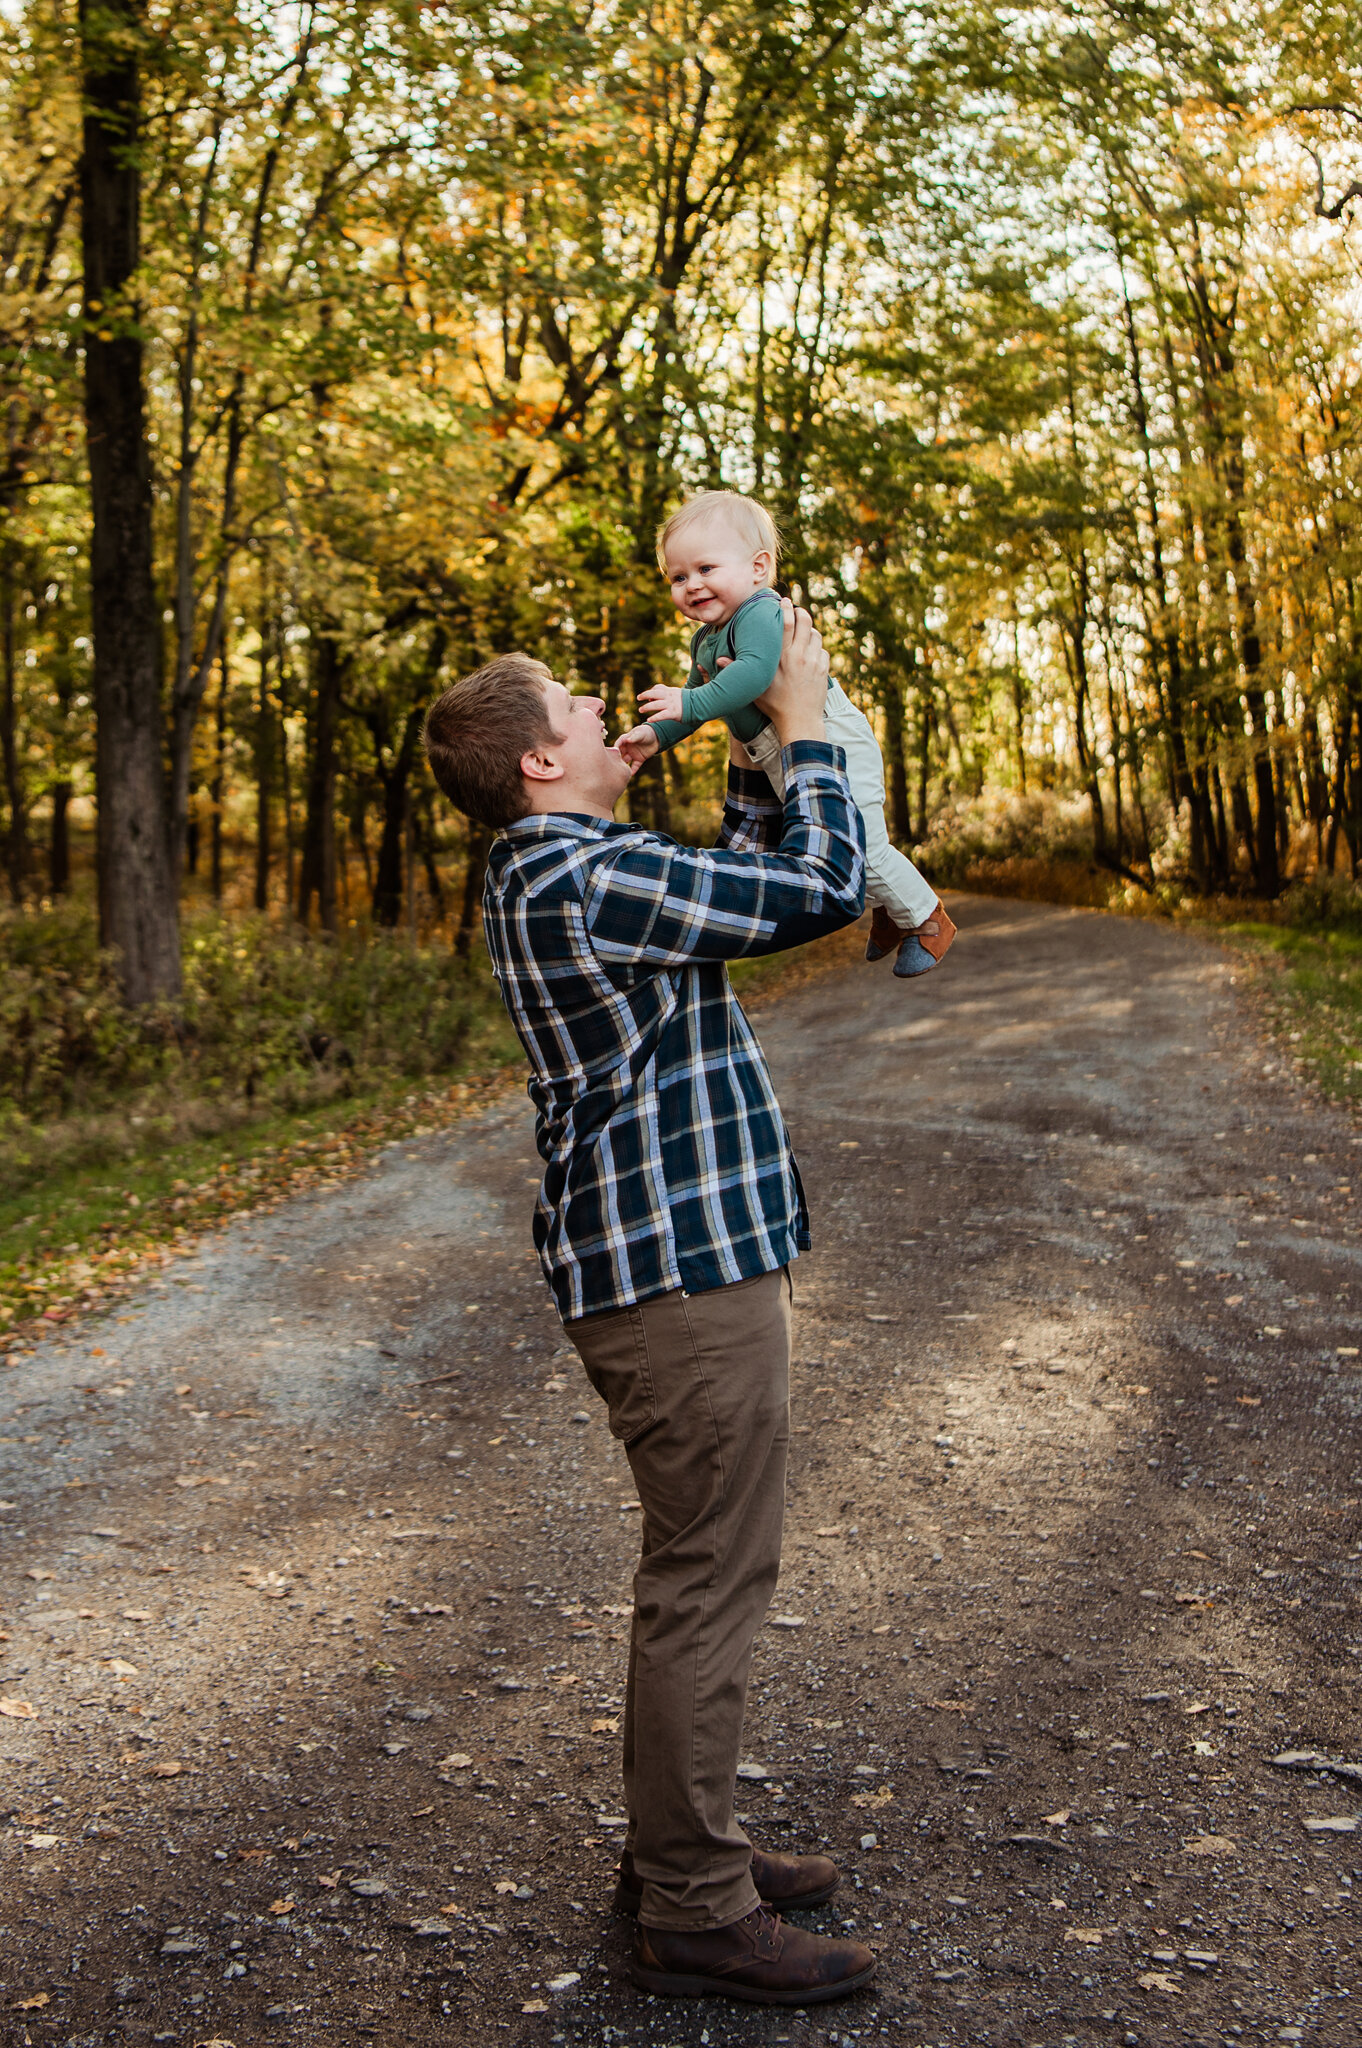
[629,1907,875,2005]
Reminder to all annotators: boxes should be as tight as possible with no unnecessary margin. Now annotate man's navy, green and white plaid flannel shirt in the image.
[483,739,864,1321]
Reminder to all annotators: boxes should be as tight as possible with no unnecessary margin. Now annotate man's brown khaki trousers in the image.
[567,1270,791,1931]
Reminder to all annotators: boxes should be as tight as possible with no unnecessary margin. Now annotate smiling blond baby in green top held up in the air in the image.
[619,492,954,975]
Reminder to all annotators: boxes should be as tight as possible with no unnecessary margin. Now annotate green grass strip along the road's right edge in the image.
[1217,924,1362,1110]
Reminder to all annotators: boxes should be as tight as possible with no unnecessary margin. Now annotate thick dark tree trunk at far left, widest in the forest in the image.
[80,0,180,1004]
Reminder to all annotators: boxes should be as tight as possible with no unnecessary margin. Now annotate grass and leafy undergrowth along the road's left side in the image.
[0,903,518,1348]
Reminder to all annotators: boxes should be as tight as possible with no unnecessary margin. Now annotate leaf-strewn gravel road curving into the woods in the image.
[0,899,1362,2048]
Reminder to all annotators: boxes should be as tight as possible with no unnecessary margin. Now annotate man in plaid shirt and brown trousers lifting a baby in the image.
[426,604,875,2005]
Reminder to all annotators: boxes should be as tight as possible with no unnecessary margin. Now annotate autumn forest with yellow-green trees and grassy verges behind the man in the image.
[0,0,1362,1346]
